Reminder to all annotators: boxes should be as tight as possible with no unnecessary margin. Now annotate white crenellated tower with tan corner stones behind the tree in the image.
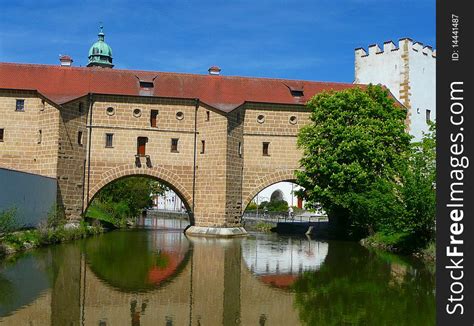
[354,38,436,141]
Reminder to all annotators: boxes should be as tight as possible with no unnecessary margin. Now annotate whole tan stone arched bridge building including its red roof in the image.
[0,63,354,235]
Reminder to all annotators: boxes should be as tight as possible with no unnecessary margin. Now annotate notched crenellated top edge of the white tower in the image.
[354,38,436,58]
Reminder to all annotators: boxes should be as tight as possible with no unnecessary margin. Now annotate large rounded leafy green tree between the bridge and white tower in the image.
[297,85,411,237]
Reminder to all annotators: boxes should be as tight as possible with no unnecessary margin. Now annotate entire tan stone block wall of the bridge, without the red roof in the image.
[0,91,309,227]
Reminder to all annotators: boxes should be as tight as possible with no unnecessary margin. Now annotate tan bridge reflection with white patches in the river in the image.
[0,233,327,325]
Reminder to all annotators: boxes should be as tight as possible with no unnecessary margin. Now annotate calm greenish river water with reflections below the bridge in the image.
[0,225,435,326]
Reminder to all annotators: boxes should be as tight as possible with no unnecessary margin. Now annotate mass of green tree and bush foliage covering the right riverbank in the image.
[297,85,436,249]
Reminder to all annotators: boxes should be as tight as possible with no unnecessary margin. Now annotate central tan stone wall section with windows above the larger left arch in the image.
[84,95,195,218]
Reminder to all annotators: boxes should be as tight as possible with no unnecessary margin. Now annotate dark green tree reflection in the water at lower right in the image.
[294,245,435,325]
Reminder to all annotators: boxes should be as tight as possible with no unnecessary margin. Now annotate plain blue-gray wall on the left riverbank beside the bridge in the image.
[0,168,57,226]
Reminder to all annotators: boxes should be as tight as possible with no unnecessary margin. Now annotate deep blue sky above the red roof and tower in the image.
[0,0,435,82]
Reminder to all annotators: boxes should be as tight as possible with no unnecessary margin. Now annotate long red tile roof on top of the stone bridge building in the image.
[0,63,355,112]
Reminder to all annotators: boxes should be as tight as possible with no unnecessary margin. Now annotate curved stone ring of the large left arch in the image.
[84,164,194,225]
